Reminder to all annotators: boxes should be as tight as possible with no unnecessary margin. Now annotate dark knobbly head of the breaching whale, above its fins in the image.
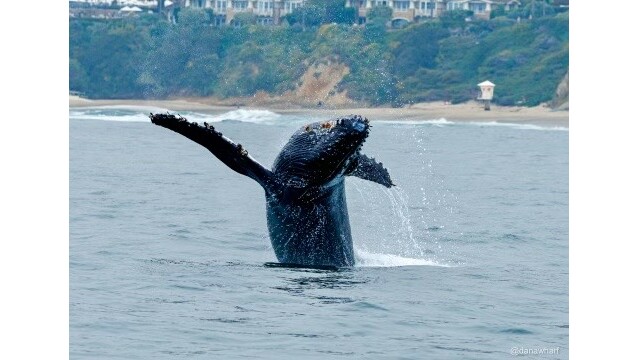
[272,115,370,188]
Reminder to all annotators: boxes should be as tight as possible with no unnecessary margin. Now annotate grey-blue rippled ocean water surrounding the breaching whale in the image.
[69,107,569,359]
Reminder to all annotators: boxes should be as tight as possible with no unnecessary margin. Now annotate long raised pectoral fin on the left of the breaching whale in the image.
[150,114,275,190]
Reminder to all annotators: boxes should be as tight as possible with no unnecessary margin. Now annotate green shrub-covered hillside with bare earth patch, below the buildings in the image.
[69,5,569,106]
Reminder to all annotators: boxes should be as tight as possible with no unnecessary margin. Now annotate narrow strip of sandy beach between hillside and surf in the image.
[69,96,569,128]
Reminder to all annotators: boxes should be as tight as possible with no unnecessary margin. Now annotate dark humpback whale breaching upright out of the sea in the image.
[151,114,394,267]
